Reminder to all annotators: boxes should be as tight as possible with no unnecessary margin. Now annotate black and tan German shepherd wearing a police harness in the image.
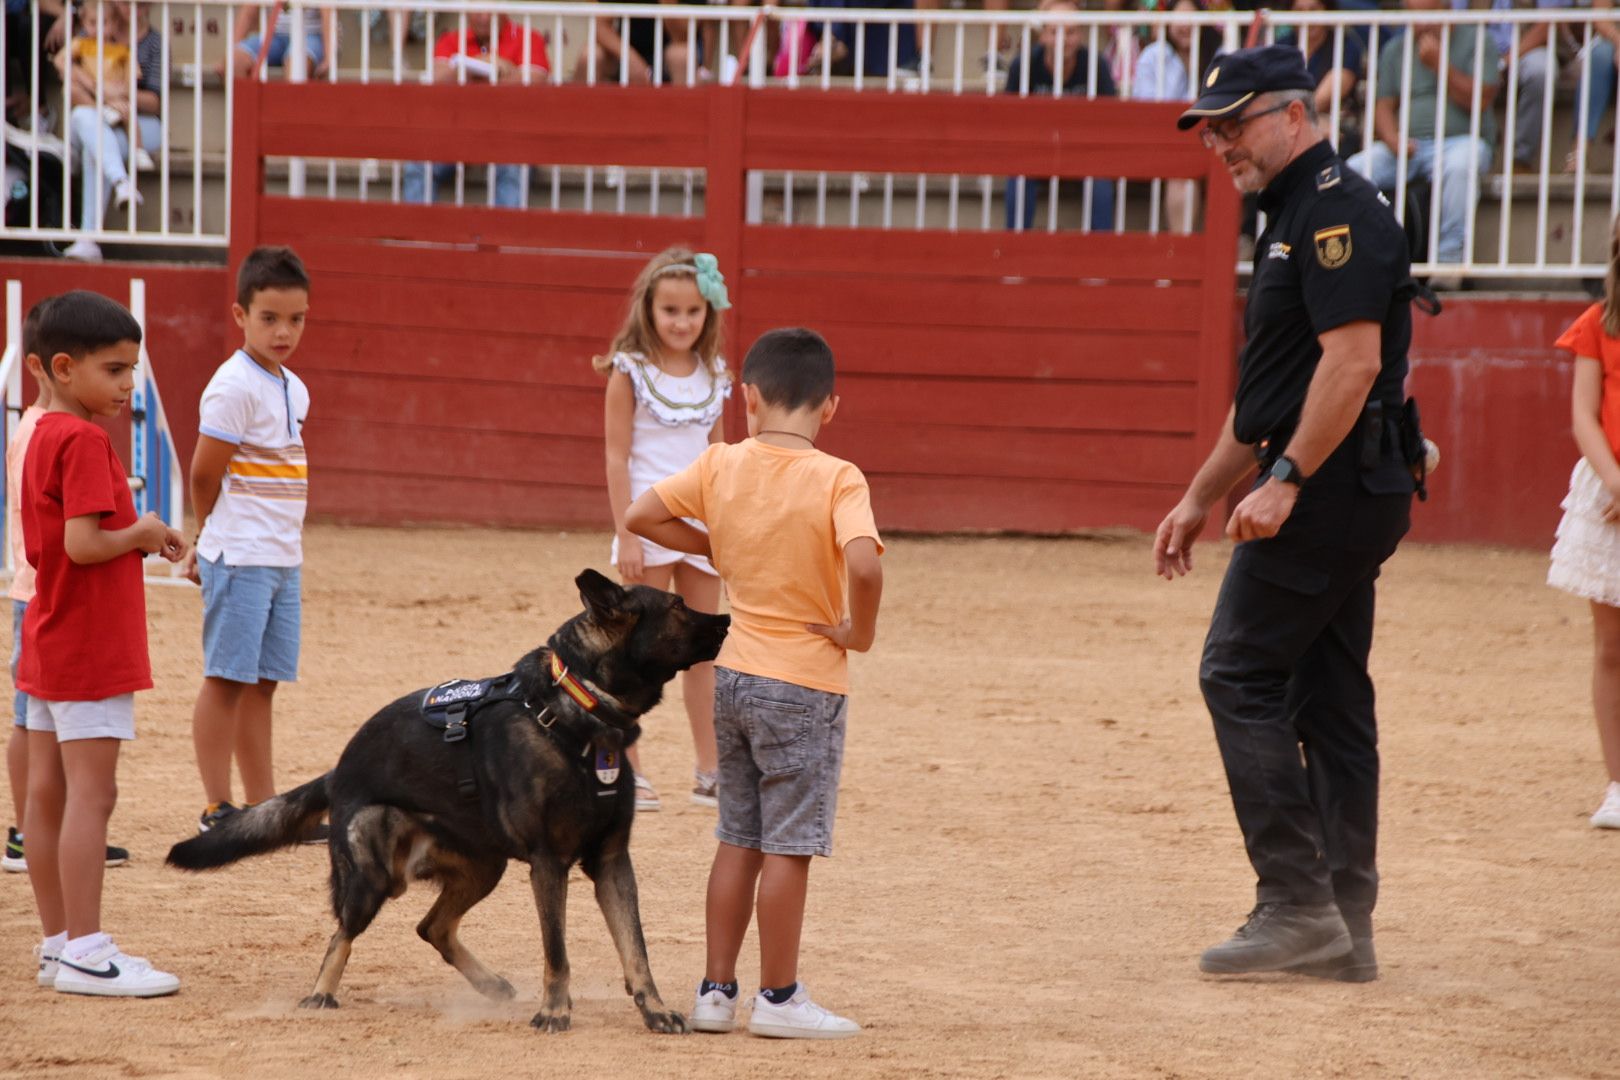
[168,570,731,1031]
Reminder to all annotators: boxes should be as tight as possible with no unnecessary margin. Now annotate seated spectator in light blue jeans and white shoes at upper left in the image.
[57,0,164,261]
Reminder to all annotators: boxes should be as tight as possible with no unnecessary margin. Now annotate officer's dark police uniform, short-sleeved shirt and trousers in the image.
[1199,141,1414,941]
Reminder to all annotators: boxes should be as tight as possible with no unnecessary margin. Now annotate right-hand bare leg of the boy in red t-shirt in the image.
[57,738,120,939]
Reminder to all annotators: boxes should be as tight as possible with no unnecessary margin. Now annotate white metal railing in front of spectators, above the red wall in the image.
[9,0,1620,280]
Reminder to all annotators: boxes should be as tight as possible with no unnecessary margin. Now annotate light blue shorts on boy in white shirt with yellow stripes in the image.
[198,555,303,683]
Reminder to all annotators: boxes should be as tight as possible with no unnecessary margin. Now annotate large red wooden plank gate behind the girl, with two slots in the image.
[232,81,1238,531]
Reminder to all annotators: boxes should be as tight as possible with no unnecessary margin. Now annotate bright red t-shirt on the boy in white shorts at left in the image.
[16,413,152,701]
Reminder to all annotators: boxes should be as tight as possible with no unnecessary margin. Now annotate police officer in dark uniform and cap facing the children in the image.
[1153,45,1414,981]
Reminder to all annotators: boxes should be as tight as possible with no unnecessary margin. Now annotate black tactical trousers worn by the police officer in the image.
[1199,469,1411,921]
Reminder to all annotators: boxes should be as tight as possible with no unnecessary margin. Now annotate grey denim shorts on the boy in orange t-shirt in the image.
[714,667,849,855]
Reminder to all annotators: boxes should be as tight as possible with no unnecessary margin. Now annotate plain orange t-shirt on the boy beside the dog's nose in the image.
[653,439,883,693]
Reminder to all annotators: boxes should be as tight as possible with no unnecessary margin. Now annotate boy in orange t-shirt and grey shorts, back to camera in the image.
[625,323,883,1038]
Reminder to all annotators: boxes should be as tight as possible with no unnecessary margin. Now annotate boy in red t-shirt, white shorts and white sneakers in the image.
[16,291,185,997]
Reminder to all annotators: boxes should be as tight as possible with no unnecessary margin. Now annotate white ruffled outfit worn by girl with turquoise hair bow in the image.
[611,353,731,573]
